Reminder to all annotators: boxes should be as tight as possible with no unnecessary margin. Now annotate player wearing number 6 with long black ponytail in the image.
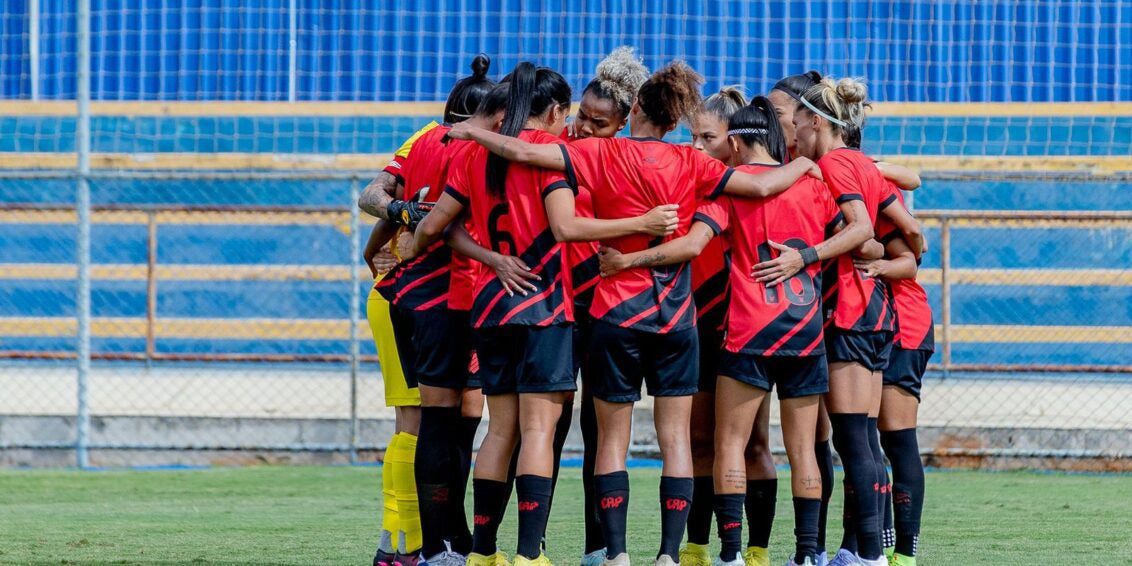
[415,62,677,565]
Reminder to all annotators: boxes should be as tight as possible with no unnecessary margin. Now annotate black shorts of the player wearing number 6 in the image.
[475,324,577,395]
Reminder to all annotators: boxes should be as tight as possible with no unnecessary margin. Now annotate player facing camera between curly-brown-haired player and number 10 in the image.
[680,87,778,566]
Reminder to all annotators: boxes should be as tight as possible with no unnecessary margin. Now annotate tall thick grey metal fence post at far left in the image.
[75,0,91,468]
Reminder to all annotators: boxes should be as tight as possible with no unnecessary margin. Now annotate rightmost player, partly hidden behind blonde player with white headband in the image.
[856,188,935,566]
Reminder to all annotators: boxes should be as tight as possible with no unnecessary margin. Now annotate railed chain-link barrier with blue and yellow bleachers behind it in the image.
[0,171,1132,469]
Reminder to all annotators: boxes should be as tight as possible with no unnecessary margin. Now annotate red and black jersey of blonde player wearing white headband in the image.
[817,147,894,332]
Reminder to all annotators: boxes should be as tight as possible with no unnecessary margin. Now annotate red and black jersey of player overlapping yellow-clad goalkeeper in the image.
[377,125,453,310]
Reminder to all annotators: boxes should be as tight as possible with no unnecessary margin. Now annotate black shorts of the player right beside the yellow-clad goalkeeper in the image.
[389,306,480,389]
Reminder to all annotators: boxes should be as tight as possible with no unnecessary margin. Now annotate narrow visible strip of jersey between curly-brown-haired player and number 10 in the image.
[692,202,741,331]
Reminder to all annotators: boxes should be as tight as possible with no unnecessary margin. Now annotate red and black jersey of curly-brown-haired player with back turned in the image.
[563,138,732,334]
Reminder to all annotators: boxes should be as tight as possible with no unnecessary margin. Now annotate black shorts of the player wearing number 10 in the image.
[719,351,830,400]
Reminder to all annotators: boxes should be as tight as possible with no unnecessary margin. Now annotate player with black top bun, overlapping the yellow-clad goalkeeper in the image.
[372,55,494,566]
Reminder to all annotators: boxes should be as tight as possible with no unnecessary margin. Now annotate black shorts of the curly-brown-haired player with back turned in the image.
[590,320,700,403]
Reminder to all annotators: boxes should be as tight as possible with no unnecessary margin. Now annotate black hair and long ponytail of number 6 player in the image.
[487,61,571,198]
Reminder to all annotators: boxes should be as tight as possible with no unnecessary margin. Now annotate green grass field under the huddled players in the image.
[0,466,1132,565]
